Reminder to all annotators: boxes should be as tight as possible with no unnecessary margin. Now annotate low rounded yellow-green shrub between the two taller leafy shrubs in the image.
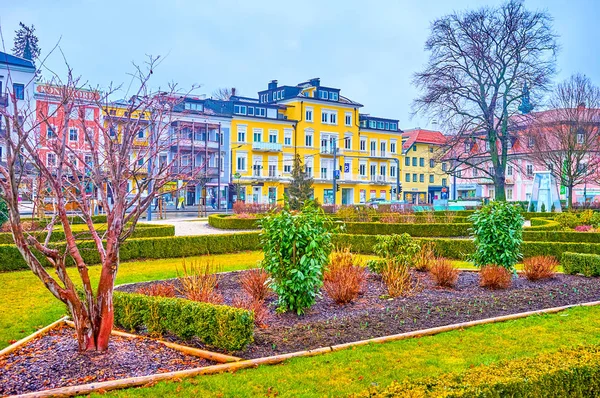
[367,233,421,274]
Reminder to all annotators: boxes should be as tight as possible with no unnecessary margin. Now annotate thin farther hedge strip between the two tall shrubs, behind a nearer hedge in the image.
[344,222,471,237]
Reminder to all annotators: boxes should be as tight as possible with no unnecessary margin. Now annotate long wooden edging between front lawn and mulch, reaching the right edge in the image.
[12,301,600,398]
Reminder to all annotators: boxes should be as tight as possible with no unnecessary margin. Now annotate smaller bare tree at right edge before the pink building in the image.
[526,74,600,208]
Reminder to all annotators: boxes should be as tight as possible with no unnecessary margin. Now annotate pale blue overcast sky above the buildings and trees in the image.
[0,0,600,129]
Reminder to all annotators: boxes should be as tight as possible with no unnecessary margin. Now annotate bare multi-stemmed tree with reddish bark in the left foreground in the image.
[0,58,202,351]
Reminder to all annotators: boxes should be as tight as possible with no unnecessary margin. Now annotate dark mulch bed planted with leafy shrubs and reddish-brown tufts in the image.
[117,271,600,358]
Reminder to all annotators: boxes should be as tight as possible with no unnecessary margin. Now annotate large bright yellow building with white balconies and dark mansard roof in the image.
[231,79,401,204]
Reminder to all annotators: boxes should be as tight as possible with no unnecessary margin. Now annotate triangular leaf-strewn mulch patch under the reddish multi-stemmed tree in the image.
[0,326,214,396]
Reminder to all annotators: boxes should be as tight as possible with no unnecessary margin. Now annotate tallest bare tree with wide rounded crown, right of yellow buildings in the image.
[413,0,558,200]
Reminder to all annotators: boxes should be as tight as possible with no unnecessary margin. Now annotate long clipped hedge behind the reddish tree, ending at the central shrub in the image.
[0,232,260,272]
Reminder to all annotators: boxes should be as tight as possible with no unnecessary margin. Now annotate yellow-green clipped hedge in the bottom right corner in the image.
[359,345,600,398]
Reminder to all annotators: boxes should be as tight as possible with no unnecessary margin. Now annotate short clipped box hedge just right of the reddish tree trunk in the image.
[113,292,254,351]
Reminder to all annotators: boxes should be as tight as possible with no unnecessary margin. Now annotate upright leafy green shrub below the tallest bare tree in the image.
[469,202,524,271]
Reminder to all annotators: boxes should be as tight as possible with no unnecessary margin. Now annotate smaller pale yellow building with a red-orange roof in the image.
[402,129,449,204]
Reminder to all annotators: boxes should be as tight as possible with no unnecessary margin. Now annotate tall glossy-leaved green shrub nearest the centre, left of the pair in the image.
[260,206,333,314]
